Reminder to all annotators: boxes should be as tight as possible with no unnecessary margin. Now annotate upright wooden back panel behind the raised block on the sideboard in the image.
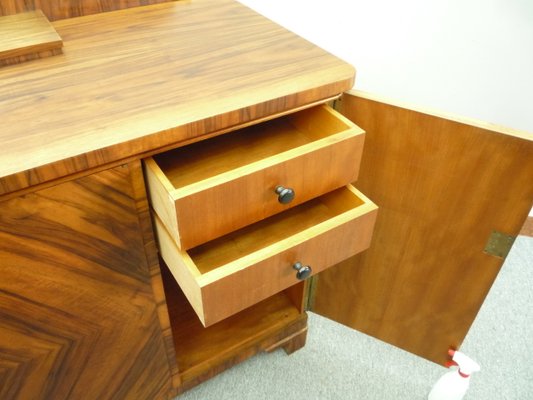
[0,0,172,21]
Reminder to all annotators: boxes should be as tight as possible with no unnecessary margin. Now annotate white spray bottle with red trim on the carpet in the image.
[428,350,480,400]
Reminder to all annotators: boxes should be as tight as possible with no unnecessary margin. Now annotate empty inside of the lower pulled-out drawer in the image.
[188,184,366,274]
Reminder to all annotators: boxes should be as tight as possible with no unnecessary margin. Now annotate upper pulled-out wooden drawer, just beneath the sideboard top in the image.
[145,105,364,249]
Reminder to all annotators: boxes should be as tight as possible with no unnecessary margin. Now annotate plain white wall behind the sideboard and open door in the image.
[240,0,533,133]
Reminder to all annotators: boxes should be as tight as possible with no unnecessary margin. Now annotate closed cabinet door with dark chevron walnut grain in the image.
[0,166,173,400]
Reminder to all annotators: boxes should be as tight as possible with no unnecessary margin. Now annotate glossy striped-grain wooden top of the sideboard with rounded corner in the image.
[0,0,354,194]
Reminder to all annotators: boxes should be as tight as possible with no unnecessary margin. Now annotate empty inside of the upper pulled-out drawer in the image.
[154,106,356,189]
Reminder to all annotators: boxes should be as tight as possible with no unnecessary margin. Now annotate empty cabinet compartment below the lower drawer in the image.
[160,260,305,382]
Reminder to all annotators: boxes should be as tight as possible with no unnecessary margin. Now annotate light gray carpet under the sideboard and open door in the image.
[178,236,533,400]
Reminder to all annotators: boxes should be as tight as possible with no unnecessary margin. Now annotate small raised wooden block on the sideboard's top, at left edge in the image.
[0,10,63,66]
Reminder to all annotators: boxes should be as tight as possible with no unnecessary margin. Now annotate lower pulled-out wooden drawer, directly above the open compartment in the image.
[154,185,377,326]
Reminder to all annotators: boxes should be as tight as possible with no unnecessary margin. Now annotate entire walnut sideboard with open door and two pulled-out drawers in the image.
[0,0,533,399]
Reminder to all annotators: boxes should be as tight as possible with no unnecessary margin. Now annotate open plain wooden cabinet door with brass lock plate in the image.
[312,92,533,364]
